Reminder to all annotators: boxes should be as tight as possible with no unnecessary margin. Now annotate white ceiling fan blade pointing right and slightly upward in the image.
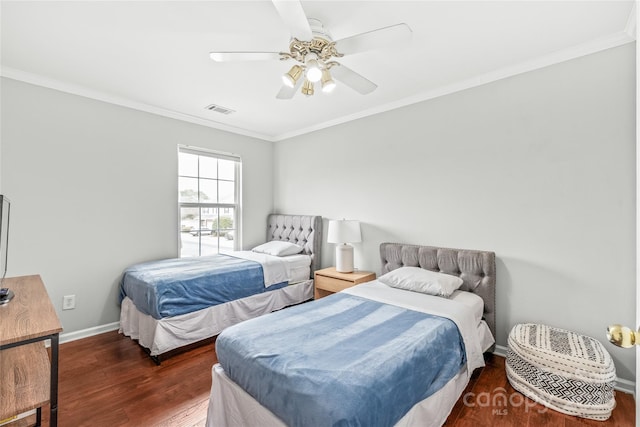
[336,24,413,54]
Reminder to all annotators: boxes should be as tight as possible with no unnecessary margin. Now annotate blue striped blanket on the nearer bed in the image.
[216,294,466,427]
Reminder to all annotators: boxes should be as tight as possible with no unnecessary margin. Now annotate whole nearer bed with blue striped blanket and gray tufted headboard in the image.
[206,243,496,427]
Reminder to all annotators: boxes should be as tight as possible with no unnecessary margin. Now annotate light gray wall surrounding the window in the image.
[0,79,273,333]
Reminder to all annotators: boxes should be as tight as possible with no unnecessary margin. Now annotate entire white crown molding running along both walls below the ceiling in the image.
[0,29,637,142]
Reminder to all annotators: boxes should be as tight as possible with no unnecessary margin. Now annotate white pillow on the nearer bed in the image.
[378,267,462,298]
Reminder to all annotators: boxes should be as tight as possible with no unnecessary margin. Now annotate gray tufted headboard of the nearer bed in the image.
[380,243,496,346]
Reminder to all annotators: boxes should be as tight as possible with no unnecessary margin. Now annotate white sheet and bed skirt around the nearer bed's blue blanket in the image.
[206,280,495,427]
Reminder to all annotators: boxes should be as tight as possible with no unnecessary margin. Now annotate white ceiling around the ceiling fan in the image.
[0,0,636,141]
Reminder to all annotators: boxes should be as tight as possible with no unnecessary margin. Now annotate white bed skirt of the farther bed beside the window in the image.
[119,280,313,356]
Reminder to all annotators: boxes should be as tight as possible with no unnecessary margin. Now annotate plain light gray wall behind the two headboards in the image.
[274,44,636,381]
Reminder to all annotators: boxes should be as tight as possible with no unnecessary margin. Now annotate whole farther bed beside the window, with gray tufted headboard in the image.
[120,214,322,363]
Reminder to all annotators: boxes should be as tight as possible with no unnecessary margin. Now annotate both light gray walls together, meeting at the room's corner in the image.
[0,44,636,380]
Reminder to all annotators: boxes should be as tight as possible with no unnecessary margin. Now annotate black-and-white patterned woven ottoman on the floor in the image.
[506,323,616,421]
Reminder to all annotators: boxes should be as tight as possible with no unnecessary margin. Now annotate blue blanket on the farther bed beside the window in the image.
[120,254,287,319]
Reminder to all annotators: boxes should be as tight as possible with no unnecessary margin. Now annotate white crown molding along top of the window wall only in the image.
[0,66,274,141]
